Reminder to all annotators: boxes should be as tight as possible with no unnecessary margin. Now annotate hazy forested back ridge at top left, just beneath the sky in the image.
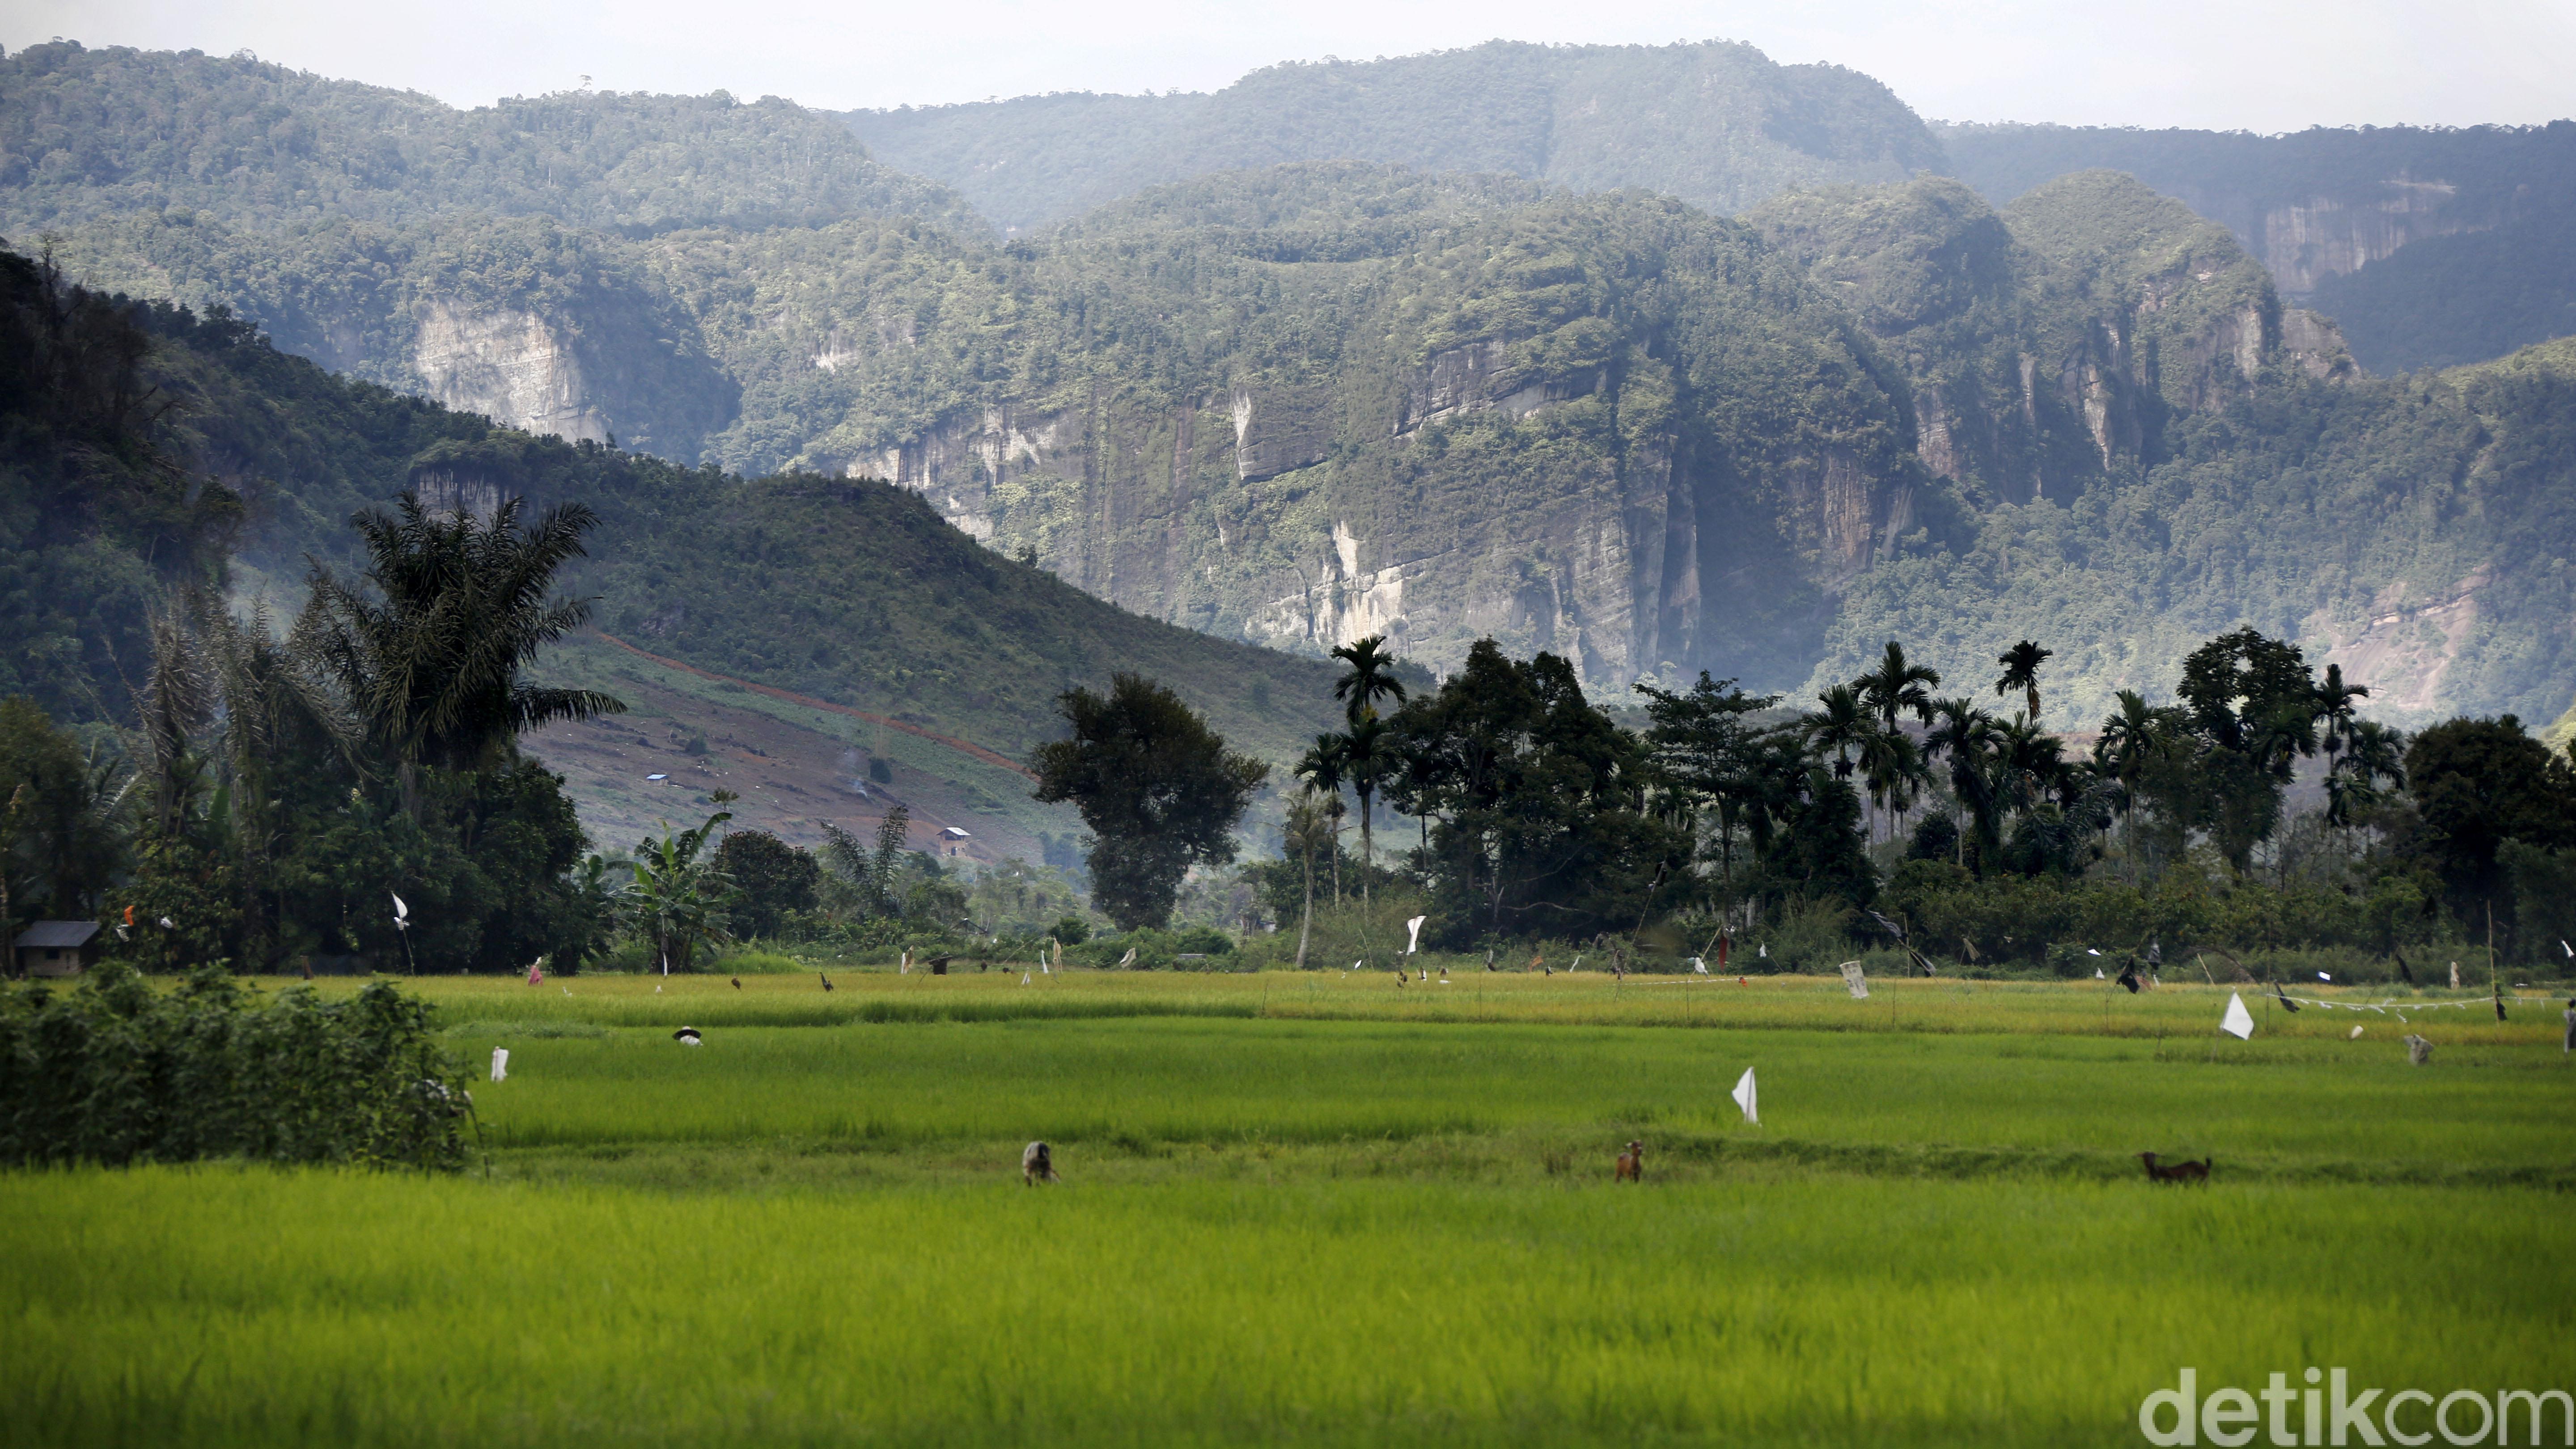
[0,41,971,235]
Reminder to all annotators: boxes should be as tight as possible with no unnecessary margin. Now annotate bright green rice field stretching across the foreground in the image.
[0,970,2576,1446]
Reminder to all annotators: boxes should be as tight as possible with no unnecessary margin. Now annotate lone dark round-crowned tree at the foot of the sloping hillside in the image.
[1030,673,1270,931]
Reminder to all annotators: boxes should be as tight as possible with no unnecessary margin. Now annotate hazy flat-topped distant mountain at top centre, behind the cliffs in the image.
[845,41,1942,235]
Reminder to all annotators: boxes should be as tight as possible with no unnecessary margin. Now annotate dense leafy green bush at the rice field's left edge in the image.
[0,962,474,1170]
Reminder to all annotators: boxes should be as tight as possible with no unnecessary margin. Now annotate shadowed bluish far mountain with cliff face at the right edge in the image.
[1935,121,2576,371]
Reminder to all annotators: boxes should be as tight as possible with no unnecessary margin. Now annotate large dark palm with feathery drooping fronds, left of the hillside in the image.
[299,492,626,794]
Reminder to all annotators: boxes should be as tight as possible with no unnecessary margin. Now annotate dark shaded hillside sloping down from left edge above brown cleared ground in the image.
[0,238,1332,799]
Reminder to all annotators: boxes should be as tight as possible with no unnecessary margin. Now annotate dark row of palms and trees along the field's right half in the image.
[1254,629,2576,970]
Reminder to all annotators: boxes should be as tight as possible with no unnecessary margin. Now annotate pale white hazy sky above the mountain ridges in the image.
[0,0,2576,131]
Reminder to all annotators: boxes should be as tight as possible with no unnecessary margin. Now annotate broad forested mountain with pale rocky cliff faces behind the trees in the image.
[0,47,2576,727]
